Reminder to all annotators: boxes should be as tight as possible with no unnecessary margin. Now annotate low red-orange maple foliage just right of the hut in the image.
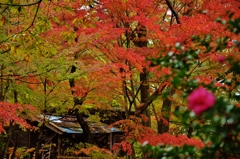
[113,117,205,155]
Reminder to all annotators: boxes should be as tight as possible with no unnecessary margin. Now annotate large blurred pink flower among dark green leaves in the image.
[188,87,215,115]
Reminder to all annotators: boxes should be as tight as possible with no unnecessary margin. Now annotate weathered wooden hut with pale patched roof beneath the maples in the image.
[36,115,123,158]
